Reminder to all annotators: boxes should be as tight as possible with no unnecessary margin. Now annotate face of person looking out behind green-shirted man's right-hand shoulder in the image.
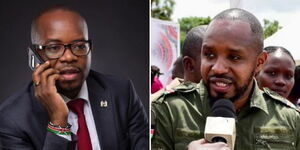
[256,50,295,98]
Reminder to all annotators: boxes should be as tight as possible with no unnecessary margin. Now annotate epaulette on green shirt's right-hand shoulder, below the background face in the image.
[263,88,300,113]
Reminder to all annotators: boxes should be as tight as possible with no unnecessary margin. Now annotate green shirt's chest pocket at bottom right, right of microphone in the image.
[254,127,296,150]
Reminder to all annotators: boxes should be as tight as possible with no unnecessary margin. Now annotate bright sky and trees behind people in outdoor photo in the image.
[151,0,300,71]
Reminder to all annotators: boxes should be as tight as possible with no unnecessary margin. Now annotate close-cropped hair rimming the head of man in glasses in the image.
[31,5,87,44]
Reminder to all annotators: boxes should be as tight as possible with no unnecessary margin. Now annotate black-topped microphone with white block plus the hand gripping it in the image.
[188,99,236,150]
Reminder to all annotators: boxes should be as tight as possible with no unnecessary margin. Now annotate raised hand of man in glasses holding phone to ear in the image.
[32,61,69,127]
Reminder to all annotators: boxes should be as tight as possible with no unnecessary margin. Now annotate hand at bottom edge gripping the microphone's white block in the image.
[188,139,230,150]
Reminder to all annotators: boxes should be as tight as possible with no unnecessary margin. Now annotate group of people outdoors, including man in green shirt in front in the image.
[151,8,300,150]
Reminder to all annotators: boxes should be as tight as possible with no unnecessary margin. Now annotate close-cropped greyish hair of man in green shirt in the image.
[212,8,264,53]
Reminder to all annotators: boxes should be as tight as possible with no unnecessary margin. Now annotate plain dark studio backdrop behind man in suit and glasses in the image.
[0,0,149,113]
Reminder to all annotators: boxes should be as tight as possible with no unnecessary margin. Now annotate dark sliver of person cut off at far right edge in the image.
[288,65,300,107]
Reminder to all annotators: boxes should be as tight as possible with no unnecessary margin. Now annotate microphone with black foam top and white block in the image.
[204,99,236,150]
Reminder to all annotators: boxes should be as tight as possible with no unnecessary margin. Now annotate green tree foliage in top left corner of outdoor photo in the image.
[151,0,175,20]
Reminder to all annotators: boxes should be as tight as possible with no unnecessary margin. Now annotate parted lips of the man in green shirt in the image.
[209,77,232,93]
